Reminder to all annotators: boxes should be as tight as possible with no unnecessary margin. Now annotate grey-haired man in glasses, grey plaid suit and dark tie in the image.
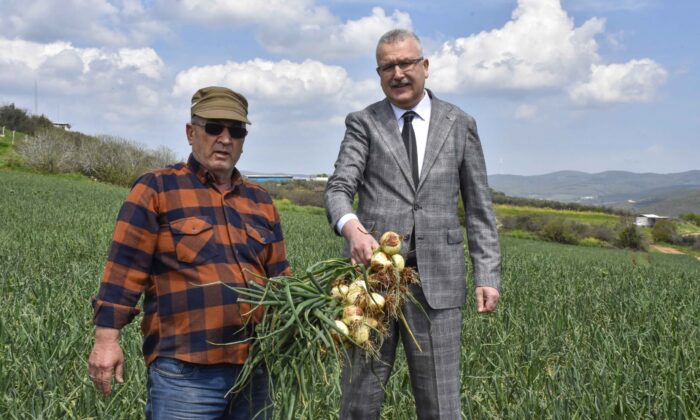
[325,30,500,420]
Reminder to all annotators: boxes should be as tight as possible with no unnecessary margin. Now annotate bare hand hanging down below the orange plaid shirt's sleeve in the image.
[88,327,124,396]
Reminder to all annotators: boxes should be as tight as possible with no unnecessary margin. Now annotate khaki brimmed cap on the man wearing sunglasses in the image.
[190,86,250,124]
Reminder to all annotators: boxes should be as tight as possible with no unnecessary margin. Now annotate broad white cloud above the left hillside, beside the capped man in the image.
[0,38,173,140]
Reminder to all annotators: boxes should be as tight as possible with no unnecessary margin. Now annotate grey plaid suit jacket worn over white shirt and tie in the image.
[325,91,500,309]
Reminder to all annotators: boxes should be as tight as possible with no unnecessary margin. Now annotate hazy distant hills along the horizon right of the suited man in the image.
[489,170,700,216]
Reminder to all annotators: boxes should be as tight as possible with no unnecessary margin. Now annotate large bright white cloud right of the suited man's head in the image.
[429,0,666,104]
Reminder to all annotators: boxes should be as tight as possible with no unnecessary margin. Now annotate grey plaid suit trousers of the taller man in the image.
[340,286,462,420]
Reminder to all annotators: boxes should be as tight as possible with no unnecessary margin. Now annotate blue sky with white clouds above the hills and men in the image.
[0,0,700,175]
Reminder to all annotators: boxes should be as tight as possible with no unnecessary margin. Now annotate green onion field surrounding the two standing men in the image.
[0,171,700,420]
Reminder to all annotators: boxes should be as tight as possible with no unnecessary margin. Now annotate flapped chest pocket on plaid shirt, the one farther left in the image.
[170,217,218,264]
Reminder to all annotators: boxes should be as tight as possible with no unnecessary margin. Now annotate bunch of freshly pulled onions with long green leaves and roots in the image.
[210,234,418,418]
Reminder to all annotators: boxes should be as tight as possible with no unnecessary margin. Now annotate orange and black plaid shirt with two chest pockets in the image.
[93,155,290,364]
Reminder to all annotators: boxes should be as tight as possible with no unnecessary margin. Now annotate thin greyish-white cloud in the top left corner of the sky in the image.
[0,0,170,47]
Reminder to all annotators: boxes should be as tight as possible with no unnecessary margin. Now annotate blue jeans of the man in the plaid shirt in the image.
[146,357,272,420]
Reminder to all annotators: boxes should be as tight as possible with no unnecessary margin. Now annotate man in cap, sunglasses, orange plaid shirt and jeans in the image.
[89,86,290,419]
